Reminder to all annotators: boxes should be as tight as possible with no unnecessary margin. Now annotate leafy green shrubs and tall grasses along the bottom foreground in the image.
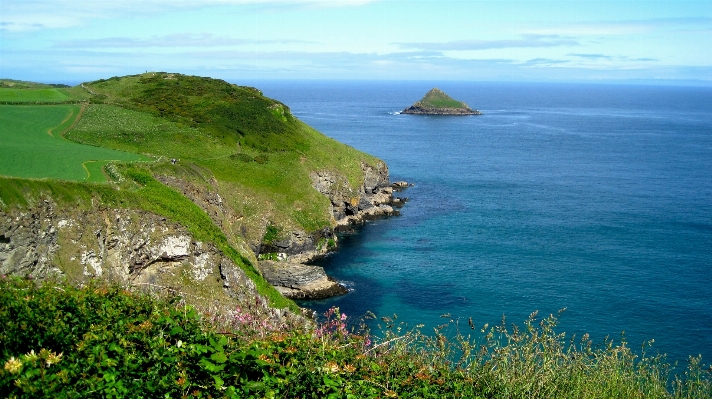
[0,277,712,398]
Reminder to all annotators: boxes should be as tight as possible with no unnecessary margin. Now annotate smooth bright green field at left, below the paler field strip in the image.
[0,105,149,182]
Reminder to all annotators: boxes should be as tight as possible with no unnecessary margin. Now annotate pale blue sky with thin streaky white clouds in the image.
[0,0,712,85]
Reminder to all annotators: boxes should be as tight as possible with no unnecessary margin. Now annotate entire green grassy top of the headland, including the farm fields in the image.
[0,72,382,310]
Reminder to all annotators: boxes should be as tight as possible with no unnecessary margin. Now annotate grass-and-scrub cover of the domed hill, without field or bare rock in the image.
[67,73,377,239]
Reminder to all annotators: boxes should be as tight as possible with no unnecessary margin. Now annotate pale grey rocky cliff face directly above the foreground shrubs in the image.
[0,200,294,322]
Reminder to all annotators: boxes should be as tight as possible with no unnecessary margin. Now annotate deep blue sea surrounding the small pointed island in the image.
[252,81,712,364]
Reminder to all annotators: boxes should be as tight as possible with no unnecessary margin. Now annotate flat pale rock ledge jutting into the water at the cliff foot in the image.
[259,260,348,299]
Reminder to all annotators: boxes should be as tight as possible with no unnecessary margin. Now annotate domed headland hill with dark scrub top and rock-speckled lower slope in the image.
[67,73,398,255]
